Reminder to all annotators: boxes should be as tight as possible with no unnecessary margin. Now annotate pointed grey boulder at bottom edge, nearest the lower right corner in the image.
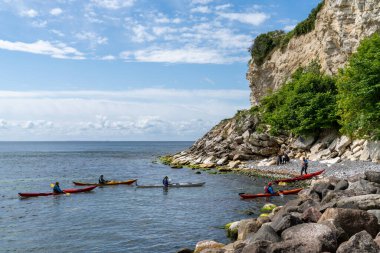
[336,230,380,253]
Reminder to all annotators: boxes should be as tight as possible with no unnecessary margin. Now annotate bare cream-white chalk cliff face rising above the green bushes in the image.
[247,0,380,105]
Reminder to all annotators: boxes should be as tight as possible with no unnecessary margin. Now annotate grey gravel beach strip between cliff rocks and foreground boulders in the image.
[246,159,380,179]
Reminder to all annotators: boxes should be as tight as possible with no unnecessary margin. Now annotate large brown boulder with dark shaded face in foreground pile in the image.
[318,208,378,236]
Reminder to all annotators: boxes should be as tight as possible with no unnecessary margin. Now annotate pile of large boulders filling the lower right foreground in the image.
[188,171,380,253]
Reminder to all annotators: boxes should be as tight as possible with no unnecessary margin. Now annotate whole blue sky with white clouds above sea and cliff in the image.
[0,0,319,141]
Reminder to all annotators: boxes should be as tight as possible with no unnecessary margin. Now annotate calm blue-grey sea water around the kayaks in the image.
[0,142,292,253]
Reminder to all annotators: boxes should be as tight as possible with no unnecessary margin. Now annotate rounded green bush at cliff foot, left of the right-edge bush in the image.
[261,62,337,135]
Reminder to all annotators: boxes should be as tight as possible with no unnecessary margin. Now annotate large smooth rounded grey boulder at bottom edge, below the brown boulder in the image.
[281,223,337,252]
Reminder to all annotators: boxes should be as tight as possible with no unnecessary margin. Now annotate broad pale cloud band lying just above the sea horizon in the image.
[0,89,249,140]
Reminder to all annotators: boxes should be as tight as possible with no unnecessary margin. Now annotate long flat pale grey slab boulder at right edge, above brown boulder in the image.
[336,194,380,210]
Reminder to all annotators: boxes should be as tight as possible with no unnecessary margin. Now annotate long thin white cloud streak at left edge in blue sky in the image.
[0,40,84,59]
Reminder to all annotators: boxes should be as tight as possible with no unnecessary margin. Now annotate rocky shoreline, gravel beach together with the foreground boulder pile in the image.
[168,159,380,253]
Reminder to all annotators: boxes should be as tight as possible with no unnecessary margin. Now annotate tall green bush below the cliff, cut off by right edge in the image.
[337,33,380,140]
